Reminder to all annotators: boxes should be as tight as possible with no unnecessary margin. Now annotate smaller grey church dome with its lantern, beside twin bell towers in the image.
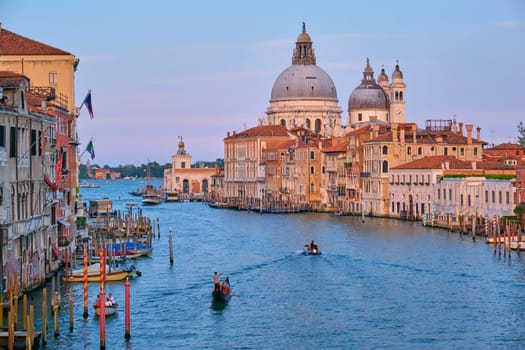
[348,59,388,111]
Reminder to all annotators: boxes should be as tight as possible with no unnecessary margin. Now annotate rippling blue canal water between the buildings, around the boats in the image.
[23,180,525,349]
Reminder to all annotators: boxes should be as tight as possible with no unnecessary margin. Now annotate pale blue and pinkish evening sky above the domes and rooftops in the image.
[0,0,525,166]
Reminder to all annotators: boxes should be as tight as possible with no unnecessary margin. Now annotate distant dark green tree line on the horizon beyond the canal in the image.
[78,158,224,179]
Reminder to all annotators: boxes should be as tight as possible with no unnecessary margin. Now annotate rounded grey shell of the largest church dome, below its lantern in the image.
[271,64,337,101]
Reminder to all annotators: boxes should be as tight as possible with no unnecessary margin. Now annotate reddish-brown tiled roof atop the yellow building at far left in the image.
[0,28,71,55]
